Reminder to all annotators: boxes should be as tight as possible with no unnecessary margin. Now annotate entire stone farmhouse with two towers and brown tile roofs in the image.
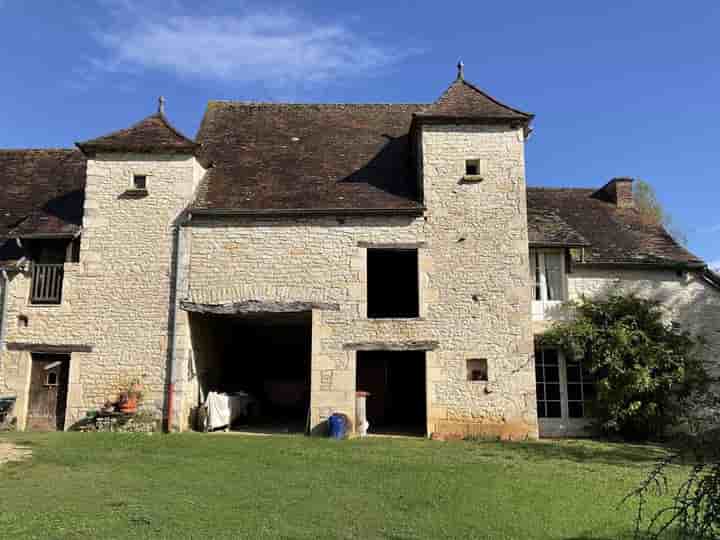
[0,67,720,438]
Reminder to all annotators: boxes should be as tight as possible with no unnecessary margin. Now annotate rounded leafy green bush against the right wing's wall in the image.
[541,294,708,439]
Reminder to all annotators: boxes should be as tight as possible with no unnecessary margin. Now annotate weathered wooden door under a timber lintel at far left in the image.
[27,353,70,431]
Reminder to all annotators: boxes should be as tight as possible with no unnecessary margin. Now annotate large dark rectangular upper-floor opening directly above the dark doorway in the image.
[367,249,420,319]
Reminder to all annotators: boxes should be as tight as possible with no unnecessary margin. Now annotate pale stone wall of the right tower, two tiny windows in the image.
[422,125,537,436]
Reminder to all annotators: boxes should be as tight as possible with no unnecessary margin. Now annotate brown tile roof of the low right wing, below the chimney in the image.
[527,187,703,265]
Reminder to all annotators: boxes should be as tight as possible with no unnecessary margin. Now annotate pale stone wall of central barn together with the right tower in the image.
[187,126,537,437]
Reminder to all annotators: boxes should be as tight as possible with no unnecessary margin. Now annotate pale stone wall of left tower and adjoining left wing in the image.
[0,154,202,428]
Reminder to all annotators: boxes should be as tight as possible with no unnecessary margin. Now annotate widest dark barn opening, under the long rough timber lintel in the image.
[190,312,312,433]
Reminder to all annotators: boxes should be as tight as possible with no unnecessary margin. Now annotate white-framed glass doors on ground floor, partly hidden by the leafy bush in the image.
[535,348,595,423]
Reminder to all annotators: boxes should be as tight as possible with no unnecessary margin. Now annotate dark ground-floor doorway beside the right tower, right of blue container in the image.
[356,351,427,435]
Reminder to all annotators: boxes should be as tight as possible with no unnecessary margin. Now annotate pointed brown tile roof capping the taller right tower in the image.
[417,77,534,122]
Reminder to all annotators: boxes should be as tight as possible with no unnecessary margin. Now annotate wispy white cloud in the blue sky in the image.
[92,0,406,88]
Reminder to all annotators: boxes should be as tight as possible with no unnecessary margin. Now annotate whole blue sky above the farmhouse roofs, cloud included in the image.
[0,0,720,266]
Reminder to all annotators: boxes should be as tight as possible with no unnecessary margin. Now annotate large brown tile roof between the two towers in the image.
[194,101,428,212]
